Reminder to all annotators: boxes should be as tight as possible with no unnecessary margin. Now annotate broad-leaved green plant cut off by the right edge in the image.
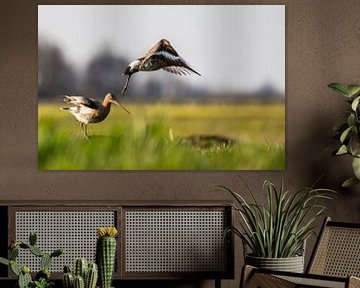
[328,83,360,187]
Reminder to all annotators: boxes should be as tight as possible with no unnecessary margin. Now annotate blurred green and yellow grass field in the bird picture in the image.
[38,104,285,170]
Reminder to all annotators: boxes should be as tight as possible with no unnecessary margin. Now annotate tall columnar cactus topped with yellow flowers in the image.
[96,227,118,288]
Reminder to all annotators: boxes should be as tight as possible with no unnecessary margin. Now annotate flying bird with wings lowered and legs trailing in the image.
[121,39,201,97]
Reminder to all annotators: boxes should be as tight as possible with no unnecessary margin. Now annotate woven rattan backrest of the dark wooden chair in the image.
[307,218,360,277]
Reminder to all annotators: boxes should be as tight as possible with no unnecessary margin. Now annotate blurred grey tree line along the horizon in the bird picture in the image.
[38,41,283,102]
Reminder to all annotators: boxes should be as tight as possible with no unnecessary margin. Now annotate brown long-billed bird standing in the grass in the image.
[60,93,120,139]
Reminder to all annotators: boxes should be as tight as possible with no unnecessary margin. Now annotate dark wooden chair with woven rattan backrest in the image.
[240,218,360,288]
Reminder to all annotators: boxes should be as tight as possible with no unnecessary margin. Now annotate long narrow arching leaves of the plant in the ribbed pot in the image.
[220,179,334,258]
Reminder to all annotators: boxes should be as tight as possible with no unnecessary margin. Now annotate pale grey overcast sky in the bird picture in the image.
[38,5,285,93]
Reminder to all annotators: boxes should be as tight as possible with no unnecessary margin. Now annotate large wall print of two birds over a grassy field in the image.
[38,5,285,170]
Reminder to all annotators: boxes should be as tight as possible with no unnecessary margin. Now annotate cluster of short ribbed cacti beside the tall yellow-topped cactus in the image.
[63,258,98,288]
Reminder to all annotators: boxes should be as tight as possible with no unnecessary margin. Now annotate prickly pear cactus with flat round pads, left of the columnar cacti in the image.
[0,233,64,288]
